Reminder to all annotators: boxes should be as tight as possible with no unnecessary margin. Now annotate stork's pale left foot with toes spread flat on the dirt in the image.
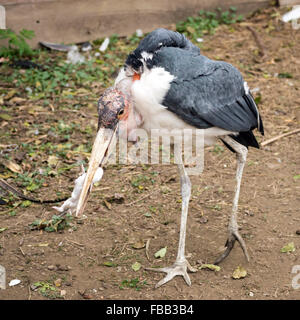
[146,259,197,288]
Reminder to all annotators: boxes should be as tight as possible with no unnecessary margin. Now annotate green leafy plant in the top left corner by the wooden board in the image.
[0,29,35,57]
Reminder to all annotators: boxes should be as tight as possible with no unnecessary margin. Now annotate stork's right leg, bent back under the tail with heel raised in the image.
[215,136,249,264]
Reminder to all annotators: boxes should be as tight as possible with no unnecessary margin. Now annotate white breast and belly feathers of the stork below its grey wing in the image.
[131,68,237,145]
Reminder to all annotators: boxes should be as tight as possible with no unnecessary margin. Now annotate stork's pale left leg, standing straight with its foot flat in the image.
[147,163,197,288]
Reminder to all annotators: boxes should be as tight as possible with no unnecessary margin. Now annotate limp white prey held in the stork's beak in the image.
[52,167,103,214]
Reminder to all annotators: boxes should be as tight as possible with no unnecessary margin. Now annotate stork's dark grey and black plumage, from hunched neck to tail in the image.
[126,29,263,147]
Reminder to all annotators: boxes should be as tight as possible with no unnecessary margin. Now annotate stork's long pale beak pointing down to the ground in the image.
[75,127,117,217]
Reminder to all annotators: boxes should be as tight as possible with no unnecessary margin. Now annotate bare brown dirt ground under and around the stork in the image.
[0,8,300,300]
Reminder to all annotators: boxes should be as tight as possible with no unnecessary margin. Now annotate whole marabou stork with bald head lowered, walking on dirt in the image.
[76,28,263,287]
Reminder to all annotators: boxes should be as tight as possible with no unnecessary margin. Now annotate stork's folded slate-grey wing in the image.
[153,48,260,132]
